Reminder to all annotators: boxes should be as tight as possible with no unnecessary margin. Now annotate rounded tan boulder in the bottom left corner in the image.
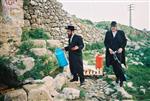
[4,89,27,101]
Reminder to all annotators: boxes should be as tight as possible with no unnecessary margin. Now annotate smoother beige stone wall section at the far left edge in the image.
[0,0,24,55]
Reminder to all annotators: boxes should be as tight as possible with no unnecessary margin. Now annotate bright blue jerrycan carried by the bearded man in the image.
[55,48,68,67]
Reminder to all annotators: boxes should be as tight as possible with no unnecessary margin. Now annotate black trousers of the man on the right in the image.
[112,54,126,82]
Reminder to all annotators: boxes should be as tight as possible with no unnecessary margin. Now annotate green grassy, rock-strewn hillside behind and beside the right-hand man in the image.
[81,19,150,101]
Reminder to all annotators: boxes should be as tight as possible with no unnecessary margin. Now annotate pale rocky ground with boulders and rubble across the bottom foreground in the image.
[0,67,132,101]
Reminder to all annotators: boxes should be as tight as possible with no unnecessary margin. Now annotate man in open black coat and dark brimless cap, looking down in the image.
[104,21,127,87]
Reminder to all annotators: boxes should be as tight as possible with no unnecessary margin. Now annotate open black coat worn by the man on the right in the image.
[104,30,127,67]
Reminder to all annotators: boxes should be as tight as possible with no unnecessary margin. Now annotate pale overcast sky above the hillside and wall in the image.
[58,0,150,30]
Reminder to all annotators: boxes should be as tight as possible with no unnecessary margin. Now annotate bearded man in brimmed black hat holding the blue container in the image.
[64,25,84,85]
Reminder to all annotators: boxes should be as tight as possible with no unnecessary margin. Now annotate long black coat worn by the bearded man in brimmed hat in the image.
[65,34,84,75]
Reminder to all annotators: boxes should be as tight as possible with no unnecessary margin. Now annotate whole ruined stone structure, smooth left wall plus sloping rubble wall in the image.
[0,0,103,55]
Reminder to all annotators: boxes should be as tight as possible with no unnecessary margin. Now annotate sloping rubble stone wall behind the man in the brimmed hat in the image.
[24,0,102,42]
